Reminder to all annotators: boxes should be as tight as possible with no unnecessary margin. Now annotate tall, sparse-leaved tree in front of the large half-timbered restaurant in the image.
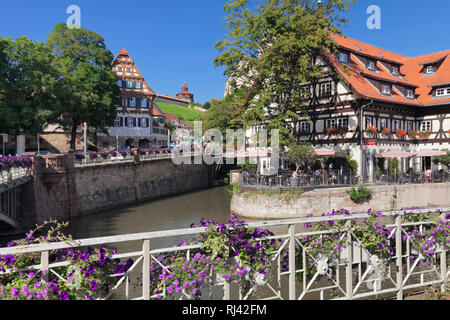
[214,0,355,146]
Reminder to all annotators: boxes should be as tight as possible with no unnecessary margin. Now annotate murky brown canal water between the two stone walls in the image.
[68,187,231,248]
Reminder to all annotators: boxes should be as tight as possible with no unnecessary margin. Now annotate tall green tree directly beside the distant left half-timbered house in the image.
[47,23,120,149]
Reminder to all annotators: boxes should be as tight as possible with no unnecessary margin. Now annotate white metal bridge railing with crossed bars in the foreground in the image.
[0,208,450,300]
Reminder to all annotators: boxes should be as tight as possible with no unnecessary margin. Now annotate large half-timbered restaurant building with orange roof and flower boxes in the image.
[243,35,450,180]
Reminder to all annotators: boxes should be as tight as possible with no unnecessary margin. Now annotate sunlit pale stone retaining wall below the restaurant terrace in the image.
[231,183,450,219]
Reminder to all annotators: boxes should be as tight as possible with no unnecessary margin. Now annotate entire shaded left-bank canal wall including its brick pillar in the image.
[17,152,213,228]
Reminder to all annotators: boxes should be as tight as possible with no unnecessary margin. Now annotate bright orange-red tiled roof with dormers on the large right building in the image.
[324,34,450,106]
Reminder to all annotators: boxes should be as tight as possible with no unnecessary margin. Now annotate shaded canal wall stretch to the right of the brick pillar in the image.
[75,159,211,214]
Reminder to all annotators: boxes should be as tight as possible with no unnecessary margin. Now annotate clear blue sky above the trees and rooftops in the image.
[0,0,450,103]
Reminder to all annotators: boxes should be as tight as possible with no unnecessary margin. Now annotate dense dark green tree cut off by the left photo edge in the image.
[0,36,60,137]
